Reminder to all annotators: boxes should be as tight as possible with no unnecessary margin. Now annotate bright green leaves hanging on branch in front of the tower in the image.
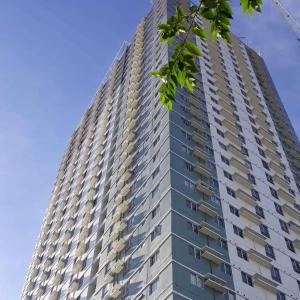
[150,0,262,110]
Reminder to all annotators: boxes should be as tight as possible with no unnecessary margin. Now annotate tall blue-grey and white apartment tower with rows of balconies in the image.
[22,0,300,300]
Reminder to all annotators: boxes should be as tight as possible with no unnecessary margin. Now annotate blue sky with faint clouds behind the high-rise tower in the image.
[0,0,300,300]
